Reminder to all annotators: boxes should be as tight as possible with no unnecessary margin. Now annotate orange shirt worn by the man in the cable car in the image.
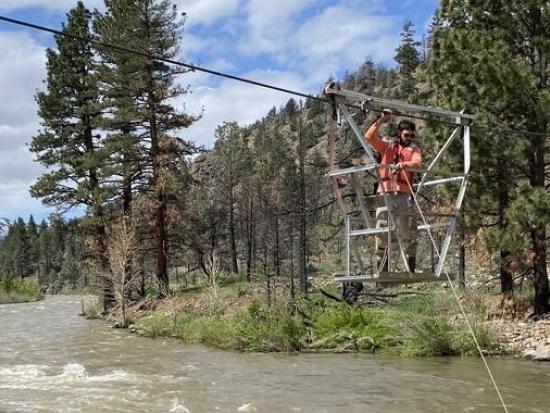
[365,123,422,193]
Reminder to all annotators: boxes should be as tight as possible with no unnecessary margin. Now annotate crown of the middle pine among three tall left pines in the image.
[94,0,147,212]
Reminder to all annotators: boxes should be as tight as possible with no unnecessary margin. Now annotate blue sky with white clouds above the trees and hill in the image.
[0,0,438,220]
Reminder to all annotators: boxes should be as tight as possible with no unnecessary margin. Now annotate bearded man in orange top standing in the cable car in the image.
[365,109,422,272]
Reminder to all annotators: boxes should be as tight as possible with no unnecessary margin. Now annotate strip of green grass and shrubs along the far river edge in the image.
[132,280,495,357]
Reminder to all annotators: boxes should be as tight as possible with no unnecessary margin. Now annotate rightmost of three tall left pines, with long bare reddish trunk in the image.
[96,0,201,297]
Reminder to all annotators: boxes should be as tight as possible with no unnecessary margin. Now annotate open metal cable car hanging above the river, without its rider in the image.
[325,82,475,292]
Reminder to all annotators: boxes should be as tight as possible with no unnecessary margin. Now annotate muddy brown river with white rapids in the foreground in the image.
[0,296,550,413]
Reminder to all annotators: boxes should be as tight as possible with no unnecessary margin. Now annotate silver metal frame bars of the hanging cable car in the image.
[325,83,475,283]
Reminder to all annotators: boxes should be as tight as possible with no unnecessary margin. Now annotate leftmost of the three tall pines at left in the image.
[30,2,113,307]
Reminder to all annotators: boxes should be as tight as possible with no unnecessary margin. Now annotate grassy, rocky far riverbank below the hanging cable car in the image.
[104,279,550,360]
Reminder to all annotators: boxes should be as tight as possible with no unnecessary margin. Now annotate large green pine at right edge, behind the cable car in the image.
[430,0,550,314]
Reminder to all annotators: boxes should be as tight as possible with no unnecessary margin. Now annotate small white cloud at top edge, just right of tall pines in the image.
[176,0,239,26]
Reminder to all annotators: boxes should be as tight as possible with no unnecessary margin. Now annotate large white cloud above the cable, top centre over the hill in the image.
[235,0,401,81]
